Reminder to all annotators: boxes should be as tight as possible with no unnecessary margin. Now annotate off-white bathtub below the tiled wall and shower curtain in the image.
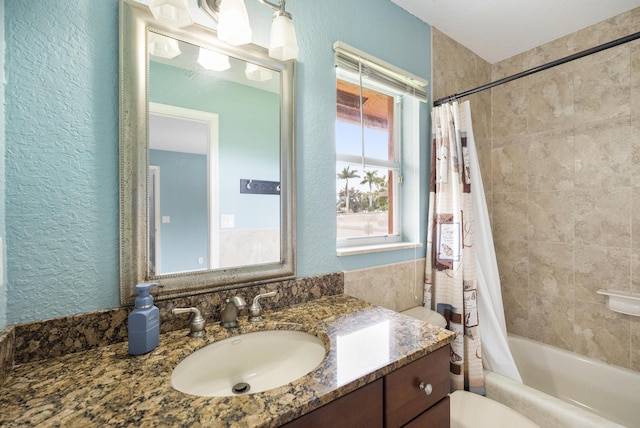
[485,335,640,428]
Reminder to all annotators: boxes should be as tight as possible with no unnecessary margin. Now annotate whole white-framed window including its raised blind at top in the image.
[335,42,426,249]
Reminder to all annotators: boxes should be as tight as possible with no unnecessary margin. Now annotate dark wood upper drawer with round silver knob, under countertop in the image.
[384,345,450,428]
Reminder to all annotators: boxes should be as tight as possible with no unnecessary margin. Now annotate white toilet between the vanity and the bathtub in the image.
[401,306,540,428]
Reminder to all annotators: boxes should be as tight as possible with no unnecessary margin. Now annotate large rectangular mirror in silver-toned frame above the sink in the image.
[120,0,295,304]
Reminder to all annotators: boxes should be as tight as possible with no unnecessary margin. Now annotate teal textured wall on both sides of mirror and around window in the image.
[0,0,431,325]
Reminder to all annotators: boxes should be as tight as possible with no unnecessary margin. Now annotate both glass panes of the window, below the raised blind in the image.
[336,76,402,244]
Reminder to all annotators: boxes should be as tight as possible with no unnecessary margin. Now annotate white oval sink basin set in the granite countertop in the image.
[171,330,326,397]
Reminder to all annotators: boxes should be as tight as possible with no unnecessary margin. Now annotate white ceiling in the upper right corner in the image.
[391,0,640,64]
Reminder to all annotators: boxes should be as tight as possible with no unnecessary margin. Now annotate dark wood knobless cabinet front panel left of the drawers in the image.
[283,379,382,428]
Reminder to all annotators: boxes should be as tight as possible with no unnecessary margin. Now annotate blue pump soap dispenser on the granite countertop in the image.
[128,283,160,355]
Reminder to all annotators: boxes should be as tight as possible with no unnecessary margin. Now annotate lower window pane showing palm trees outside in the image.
[336,162,393,239]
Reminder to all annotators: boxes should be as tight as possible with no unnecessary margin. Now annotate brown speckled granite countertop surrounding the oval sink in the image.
[0,295,454,427]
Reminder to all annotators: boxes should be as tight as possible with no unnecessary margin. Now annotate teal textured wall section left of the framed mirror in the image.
[4,0,119,323]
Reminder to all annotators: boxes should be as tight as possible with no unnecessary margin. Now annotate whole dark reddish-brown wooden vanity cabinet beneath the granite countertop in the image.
[283,345,450,428]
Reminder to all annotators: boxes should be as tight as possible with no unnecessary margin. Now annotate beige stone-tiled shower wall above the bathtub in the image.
[433,8,640,371]
